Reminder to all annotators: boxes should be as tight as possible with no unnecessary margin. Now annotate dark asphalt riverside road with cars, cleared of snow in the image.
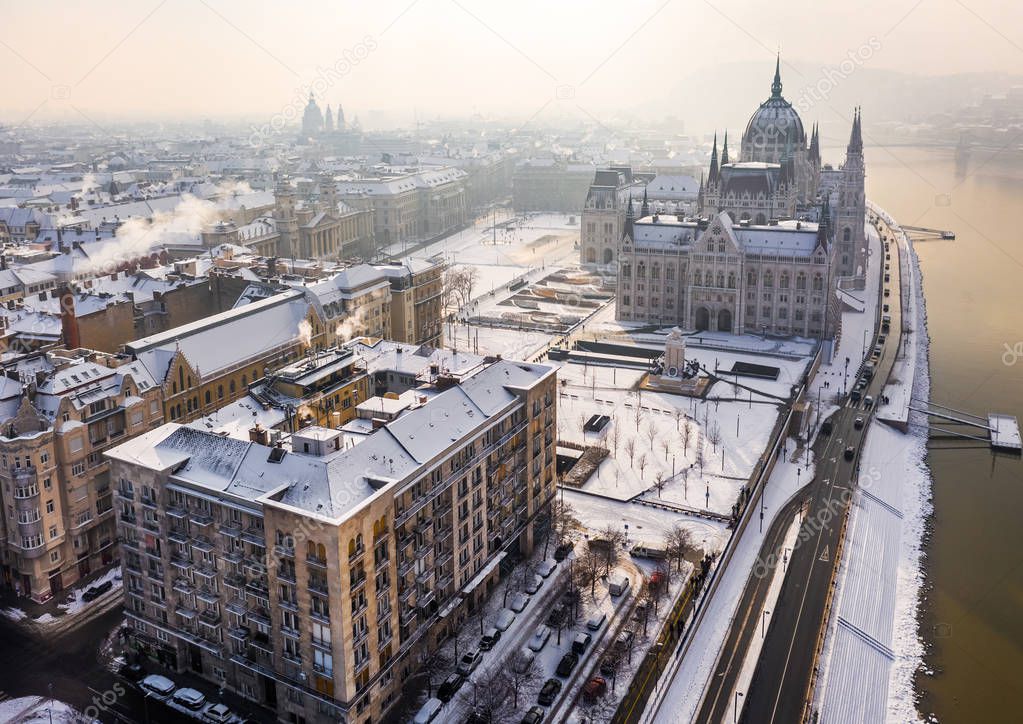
[697,220,901,724]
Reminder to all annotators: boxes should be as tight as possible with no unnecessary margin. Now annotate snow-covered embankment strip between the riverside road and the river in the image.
[815,206,930,722]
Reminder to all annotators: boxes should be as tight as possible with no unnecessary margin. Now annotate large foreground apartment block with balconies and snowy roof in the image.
[107,360,557,722]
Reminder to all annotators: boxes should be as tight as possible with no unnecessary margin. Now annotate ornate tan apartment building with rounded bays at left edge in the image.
[0,350,163,602]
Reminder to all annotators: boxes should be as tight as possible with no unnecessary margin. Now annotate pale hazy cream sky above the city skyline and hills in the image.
[0,0,1023,124]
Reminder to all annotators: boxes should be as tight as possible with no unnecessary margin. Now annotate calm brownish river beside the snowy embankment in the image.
[866,146,1023,722]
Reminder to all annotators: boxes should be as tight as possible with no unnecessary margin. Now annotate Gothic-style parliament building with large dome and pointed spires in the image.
[580,58,865,340]
